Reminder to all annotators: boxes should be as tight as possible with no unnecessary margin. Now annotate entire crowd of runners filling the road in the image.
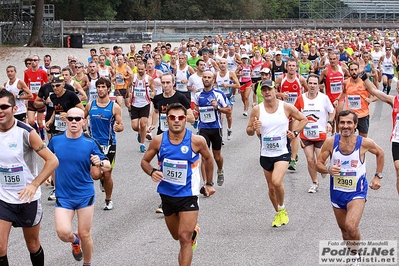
[0,27,399,266]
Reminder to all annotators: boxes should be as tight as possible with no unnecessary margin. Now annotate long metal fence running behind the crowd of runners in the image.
[0,18,399,46]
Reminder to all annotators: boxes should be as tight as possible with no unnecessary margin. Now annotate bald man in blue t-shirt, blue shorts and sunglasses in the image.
[49,108,111,266]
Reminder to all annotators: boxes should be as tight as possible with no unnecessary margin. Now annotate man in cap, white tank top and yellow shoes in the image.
[246,80,307,227]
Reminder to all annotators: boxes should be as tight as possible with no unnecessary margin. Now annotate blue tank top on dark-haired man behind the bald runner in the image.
[89,100,116,145]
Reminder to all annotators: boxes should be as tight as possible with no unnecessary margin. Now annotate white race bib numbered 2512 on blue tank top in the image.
[162,159,188,186]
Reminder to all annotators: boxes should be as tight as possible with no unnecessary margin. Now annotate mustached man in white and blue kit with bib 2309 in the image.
[316,110,384,260]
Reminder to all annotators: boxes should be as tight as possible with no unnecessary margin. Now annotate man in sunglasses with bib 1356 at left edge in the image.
[0,90,57,266]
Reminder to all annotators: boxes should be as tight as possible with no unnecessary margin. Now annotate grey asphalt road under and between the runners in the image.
[8,85,399,266]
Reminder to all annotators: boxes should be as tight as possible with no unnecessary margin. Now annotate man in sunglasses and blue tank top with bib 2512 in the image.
[141,103,215,266]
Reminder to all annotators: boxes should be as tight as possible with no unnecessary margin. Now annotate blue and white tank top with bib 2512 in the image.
[157,129,201,197]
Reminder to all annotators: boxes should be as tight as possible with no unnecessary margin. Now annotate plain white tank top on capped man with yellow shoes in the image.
[259,100,289,157]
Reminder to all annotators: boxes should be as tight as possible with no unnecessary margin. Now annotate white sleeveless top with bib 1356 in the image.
[0,119,42,204]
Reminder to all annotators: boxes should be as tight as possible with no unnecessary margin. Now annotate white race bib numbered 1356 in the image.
[0,166,26,189]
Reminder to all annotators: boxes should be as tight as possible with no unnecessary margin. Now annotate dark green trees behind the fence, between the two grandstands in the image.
[46,0,299,20]
